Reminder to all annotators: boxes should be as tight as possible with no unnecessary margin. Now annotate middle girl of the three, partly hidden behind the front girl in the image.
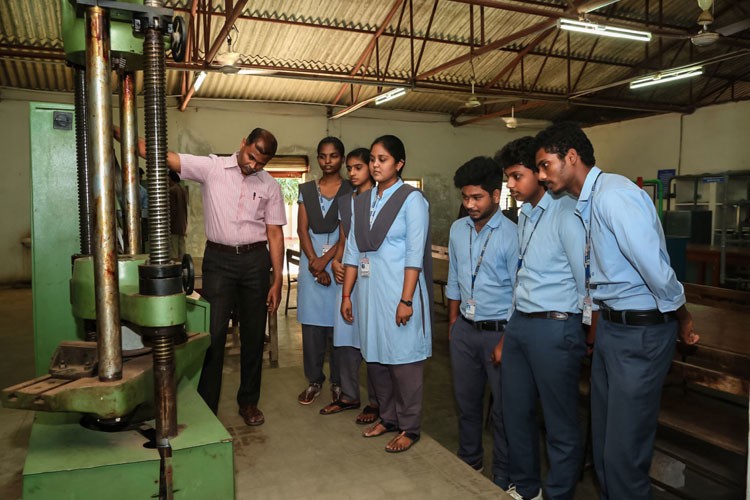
[320,148,378,418]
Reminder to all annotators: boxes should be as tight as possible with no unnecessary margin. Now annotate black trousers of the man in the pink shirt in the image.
[198,247,271,413]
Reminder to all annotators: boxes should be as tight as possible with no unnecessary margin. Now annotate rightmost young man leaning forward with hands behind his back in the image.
[536,123,699,500]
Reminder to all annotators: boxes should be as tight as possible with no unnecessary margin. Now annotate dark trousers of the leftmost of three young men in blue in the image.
[450,317,509,488]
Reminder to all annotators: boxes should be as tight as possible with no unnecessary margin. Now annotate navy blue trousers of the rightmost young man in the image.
[591,318,678,500]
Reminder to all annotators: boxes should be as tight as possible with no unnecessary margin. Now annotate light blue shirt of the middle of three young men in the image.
[515,192,586,314]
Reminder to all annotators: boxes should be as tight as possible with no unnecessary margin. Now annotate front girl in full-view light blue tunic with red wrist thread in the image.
[341,135,432,453]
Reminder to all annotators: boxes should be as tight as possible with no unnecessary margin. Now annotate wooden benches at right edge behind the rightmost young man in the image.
[656,285,750,491]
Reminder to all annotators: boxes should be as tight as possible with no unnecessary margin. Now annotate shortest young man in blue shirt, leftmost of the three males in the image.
[445,156,518,489]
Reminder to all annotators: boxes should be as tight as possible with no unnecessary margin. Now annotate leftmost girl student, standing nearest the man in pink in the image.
[297,137,352,405]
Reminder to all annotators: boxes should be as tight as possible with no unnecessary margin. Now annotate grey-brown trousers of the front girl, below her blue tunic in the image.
[367,361,424,434]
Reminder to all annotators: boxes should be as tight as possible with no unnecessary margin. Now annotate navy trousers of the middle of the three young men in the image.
[502,312,586,500]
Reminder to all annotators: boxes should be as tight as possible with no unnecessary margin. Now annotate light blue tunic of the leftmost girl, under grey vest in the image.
[297,189,339,326]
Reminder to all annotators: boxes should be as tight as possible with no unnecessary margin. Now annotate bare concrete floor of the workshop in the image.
[0,289,598,500]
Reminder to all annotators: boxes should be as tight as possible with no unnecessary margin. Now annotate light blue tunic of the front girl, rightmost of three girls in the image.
[344,179,432,365]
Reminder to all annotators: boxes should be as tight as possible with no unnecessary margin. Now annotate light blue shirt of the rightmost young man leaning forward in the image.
[577,167,685,312]
